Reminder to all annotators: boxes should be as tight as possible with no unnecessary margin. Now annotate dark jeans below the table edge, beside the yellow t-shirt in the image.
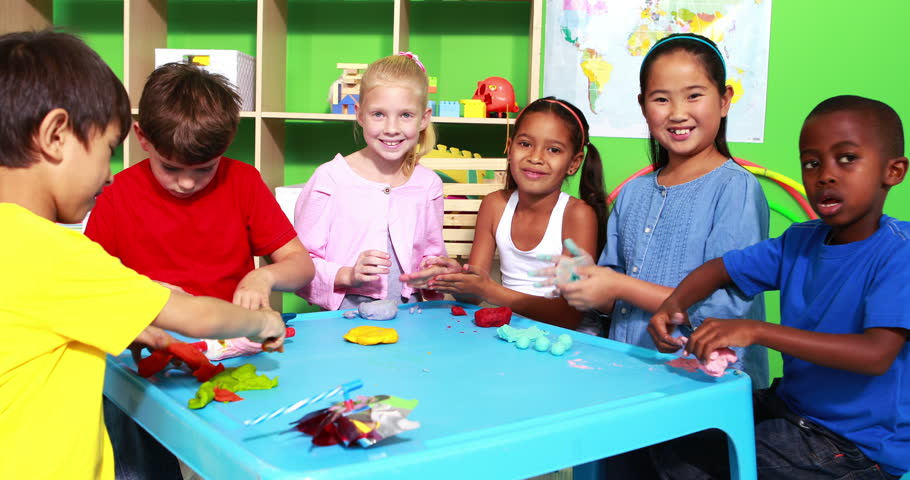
[104,397,183,480]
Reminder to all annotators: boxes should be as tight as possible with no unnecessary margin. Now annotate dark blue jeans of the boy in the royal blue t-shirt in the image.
[650,381,898,480]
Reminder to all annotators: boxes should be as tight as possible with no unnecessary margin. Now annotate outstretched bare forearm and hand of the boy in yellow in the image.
[152,291,285,350]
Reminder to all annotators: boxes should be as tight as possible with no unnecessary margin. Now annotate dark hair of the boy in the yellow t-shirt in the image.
[0,30,132,168]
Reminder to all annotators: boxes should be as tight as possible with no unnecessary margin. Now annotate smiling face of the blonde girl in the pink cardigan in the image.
[357,85,431,168]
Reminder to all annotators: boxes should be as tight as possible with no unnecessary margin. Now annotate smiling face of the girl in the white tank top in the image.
[509,112,584,195]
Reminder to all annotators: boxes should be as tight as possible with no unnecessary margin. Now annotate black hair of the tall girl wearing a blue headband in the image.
[638,33,732,170]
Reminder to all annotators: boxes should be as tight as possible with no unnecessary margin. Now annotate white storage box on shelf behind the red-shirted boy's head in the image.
[155,48,256,111]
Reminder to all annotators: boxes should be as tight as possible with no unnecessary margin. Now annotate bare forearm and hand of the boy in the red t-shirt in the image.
[234,237,315,310]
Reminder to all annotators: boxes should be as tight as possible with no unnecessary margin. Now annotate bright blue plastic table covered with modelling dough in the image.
[104,302,755,479]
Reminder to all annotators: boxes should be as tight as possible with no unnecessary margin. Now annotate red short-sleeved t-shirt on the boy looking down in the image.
[85,157,297,301]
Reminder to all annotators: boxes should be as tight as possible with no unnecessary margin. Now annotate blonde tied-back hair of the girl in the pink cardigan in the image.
[360,55,436,176]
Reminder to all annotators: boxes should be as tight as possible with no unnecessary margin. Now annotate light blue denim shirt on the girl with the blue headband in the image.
[598,160,768,388]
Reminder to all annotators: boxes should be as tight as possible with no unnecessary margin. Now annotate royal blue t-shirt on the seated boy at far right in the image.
[724,215,910,475]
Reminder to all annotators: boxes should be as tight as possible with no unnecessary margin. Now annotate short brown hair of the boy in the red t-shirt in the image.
[139,63,240,165]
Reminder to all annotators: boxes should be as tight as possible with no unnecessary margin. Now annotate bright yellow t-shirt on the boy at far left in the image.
[0,203,170,479]
